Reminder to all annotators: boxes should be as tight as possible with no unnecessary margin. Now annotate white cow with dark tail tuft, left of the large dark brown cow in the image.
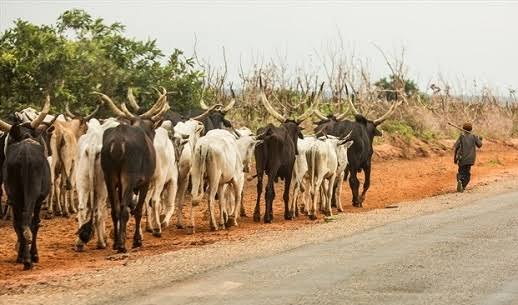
[75,119,119,251]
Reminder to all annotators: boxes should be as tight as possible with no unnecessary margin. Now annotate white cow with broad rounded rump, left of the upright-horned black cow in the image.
[191,130,245,232]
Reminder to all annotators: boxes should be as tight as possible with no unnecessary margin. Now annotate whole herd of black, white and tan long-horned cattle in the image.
[0,84,399,269]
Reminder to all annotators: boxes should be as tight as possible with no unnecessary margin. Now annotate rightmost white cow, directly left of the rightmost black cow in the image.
[306,134,353,220]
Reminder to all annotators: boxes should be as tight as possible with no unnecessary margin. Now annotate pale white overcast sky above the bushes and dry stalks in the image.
[0,0,518,94]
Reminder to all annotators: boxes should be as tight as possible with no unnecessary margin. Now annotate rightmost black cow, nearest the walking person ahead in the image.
[315,102,401,207]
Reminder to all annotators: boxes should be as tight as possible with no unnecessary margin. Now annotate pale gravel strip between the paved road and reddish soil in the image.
[0,176,518,305]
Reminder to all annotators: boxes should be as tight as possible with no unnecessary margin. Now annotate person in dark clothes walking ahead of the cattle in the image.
[453,123,482,192]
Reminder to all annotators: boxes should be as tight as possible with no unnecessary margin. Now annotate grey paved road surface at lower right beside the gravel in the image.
[119,192,518,305]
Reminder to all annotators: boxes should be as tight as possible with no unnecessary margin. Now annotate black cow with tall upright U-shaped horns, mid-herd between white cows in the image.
[254,78,324,223]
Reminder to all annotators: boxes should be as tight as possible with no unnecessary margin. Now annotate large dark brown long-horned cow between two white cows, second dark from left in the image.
[95,90,169,253]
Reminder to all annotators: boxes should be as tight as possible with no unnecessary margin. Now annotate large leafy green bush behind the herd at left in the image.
[0,10,203,117]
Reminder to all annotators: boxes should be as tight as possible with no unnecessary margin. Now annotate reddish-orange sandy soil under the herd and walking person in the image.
[0,138,518,288]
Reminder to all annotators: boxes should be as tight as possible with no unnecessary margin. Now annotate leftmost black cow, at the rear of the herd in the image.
[0,95,50,270]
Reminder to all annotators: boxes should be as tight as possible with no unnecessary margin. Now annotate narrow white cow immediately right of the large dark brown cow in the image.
[144,121,178,237]
